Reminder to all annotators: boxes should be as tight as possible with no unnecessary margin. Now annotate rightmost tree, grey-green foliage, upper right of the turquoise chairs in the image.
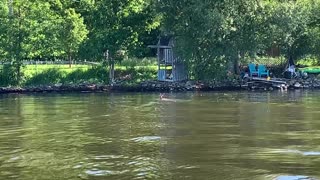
[266,1,310,61]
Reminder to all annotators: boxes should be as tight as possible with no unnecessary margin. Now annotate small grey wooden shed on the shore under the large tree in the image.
[148,36,188,82]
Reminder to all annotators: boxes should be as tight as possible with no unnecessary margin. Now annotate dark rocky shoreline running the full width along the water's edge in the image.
[0,79,320,94]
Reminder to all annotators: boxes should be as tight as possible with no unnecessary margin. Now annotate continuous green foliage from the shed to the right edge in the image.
[157,0,320,79]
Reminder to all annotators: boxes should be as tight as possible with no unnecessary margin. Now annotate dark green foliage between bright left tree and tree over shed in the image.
[80,0,160,60]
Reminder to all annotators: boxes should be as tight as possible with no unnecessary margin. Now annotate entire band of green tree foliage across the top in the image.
[0,0,320,84]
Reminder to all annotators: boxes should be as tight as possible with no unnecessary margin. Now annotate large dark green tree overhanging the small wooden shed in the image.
[158,0,263,79]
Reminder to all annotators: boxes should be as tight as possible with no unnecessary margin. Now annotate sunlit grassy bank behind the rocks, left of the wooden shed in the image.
[0,64,157,86]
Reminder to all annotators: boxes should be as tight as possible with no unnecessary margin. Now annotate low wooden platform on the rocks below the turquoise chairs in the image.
[247,77,288,89]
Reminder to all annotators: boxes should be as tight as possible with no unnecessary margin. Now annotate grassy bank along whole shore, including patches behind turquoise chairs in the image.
[0,57,319,87]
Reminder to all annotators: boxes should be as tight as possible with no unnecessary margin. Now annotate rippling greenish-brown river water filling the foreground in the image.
[0,91,320,180]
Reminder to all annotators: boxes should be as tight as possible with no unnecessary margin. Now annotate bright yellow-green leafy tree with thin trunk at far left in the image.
[0,0,87,82]
